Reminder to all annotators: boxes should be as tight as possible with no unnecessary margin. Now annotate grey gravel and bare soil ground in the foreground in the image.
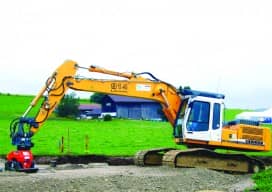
[0,157,254,192]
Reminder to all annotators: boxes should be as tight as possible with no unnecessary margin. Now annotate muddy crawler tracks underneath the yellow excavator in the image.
[135,148,265,173]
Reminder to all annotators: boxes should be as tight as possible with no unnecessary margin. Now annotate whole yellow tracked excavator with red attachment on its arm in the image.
[5,60,271,172]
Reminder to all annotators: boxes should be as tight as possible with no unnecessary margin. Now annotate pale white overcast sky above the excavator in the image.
[0,0,272,108]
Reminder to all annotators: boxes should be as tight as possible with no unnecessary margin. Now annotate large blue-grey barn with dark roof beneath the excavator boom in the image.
[102,95,163,120]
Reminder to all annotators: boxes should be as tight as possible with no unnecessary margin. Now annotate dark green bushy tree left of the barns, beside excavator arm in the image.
[56,93,79,117]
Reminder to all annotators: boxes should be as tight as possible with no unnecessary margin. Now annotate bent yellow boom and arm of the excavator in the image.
[30,61,181,133]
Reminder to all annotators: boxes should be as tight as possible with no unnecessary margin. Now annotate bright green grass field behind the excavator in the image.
[0,94,272,156]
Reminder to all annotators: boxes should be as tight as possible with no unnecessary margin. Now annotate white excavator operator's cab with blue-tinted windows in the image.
[174,89,224,141]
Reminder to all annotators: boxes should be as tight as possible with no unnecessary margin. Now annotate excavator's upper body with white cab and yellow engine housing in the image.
[174,89,271,151]
